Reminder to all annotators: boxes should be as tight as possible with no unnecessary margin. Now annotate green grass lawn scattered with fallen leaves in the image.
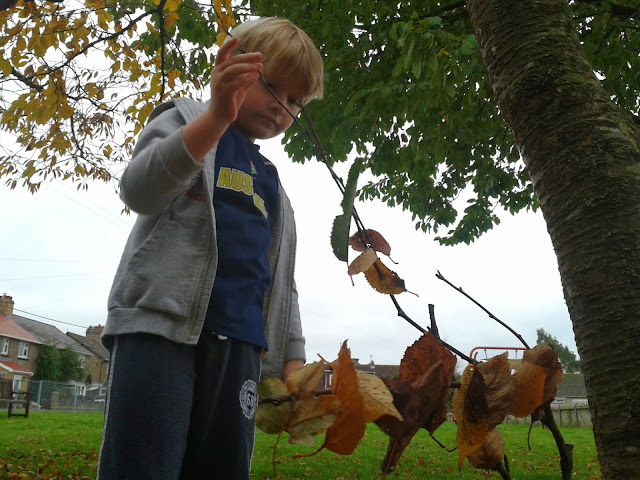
[0,410,600,480]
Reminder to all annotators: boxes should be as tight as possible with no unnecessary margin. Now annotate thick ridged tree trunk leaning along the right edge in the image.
[467,0,640,480]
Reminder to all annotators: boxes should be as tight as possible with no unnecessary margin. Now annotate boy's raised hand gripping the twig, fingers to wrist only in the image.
[209,38,262,128]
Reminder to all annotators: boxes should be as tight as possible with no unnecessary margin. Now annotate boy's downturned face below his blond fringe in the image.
[233,71,304,142]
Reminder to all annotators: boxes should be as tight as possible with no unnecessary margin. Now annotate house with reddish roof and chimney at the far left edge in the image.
[0,295,41,391]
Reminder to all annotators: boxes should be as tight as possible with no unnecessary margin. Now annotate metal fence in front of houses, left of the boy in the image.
[27,380,104,412]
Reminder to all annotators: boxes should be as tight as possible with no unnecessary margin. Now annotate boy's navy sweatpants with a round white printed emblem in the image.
[97,332,260,480]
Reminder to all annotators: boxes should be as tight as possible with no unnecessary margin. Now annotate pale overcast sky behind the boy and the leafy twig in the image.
[0,139,577,365]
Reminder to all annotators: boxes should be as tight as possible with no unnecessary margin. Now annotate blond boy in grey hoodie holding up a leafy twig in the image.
[98,18,323,480]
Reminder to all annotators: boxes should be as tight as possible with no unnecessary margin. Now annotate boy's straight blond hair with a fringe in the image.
[231,17,324,103]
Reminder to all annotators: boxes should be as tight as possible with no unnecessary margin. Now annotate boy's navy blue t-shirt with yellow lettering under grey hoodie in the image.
[204,127,279,350]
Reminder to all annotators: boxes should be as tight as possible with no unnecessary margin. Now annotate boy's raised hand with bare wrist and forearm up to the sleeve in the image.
[182,38,262,162]
